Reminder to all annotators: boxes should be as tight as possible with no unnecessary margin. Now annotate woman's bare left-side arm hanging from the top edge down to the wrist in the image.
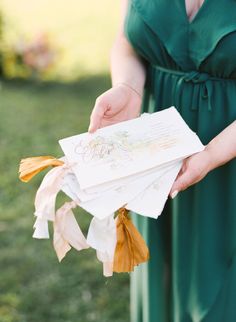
[111,0,146,95]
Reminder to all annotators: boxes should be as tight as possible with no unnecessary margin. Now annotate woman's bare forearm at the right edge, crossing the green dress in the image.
[205,121,236,170]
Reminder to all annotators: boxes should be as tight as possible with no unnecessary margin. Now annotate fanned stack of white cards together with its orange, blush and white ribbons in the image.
[20,107,204,276]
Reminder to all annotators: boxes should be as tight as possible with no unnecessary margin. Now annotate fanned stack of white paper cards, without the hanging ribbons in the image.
[59,107,204,219]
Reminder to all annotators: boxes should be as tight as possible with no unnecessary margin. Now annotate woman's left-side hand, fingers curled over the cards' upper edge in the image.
[89,84,142,133]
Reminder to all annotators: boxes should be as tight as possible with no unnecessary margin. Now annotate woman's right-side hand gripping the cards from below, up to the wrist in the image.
[170,149,213,198]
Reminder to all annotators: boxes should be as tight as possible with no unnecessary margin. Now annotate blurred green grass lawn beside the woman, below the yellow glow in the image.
[0,76,129,322]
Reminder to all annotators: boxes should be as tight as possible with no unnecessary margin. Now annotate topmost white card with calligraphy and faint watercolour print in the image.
[59,107,204,190]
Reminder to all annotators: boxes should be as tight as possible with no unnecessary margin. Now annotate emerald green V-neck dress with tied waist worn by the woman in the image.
[125,0,236,322]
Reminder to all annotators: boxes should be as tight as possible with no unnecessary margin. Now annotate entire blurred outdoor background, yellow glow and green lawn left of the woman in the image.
[0,0,129,322]
